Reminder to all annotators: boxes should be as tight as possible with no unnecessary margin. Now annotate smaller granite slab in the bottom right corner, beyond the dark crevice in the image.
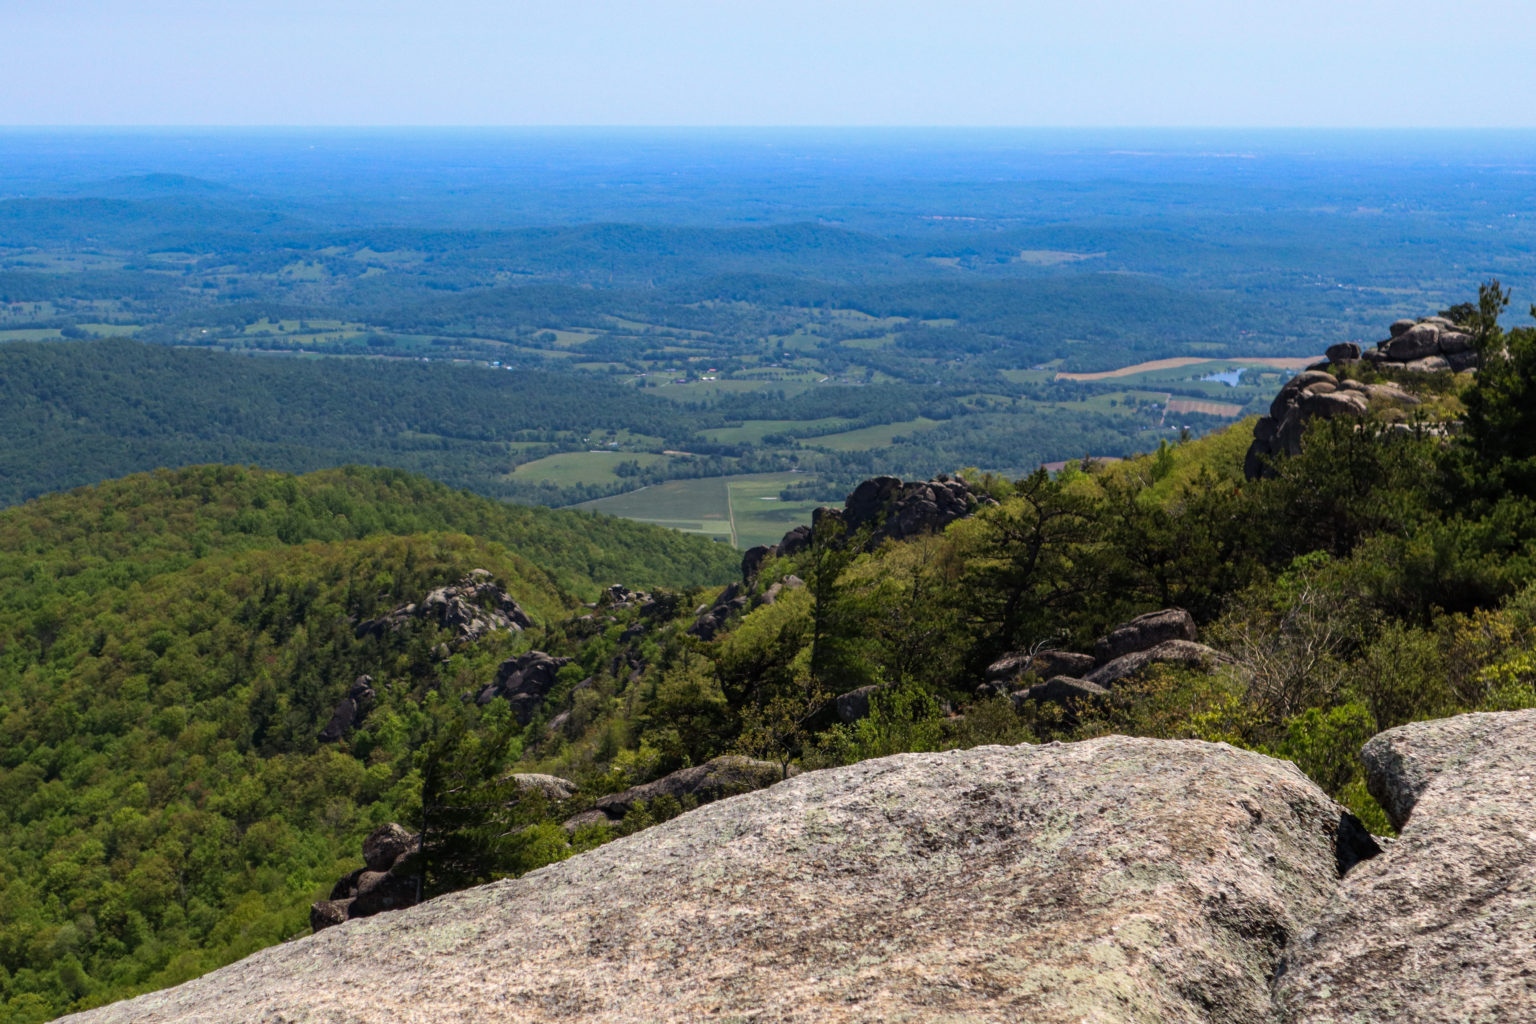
[1276,711,1536,1024]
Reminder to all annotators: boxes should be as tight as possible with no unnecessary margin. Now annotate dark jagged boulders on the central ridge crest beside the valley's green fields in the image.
[742,476,997,580]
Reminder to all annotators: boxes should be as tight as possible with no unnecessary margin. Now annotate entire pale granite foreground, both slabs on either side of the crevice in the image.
[56,712,1536,1024]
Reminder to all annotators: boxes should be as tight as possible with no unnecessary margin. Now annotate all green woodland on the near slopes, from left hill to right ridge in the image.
[0,287,1536,1022]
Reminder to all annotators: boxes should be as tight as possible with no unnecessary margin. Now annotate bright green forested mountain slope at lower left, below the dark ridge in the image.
[0,467,736,1021]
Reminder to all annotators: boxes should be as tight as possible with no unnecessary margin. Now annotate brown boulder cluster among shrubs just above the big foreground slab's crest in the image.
[985,608,1229,705]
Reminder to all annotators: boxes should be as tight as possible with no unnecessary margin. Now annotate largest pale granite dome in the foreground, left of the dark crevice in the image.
[69,737,1339,1024]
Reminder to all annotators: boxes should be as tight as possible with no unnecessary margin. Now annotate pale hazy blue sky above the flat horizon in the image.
[0,0,1536,127]
